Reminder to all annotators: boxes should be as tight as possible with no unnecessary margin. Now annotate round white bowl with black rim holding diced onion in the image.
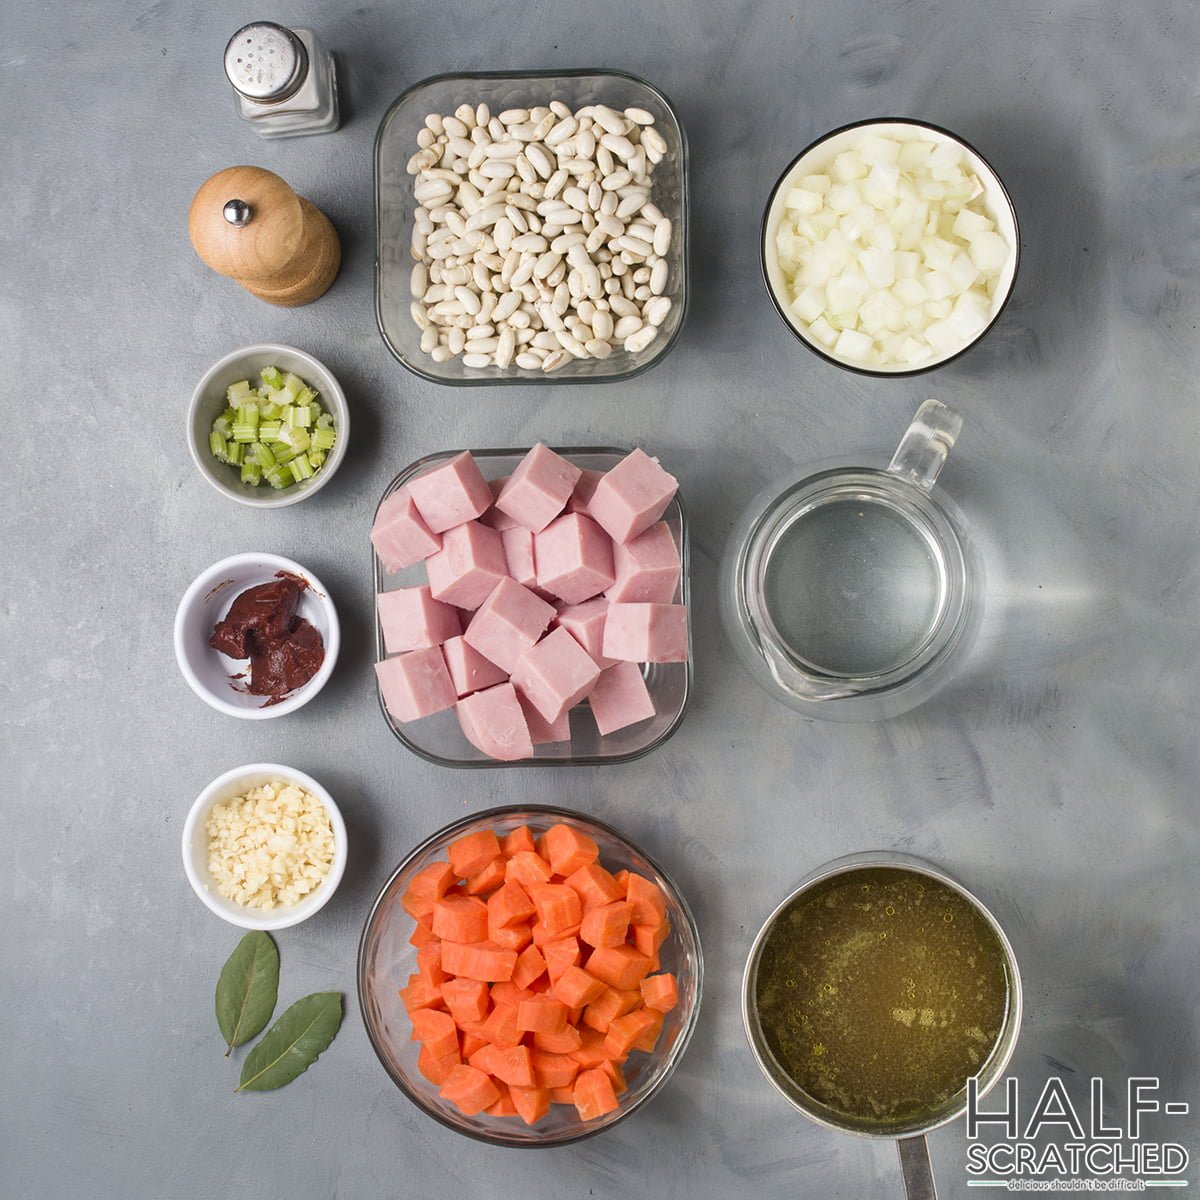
[760,116,1021,377]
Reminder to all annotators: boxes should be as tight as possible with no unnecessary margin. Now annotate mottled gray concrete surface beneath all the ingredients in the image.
[0,0,1200,1200]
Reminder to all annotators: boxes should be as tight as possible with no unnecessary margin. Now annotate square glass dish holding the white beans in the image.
[374,71,688,386]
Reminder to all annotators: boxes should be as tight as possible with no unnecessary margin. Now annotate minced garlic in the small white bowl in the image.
[206,779,335,908]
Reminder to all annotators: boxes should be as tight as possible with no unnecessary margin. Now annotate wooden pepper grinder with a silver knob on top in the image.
[187,167,342,308]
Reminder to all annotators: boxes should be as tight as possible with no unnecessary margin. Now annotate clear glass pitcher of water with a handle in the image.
[721,400,980,721]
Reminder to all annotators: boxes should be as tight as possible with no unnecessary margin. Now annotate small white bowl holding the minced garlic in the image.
[182,762,349,930]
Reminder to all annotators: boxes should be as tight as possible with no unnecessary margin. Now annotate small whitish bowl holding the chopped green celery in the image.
[187,342,350,509]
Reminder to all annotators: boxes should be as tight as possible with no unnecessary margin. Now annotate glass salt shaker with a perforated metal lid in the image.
[224,20,338,138]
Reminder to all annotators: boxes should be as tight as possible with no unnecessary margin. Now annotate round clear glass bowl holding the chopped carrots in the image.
[359,806,704,1146]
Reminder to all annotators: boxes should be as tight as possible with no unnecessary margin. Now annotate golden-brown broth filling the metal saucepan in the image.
[755,868,1009,1129]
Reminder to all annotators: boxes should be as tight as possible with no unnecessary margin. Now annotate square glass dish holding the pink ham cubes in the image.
[371,446,692,767]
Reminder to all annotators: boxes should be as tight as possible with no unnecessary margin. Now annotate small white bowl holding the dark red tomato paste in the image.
[175,554,342,721]
